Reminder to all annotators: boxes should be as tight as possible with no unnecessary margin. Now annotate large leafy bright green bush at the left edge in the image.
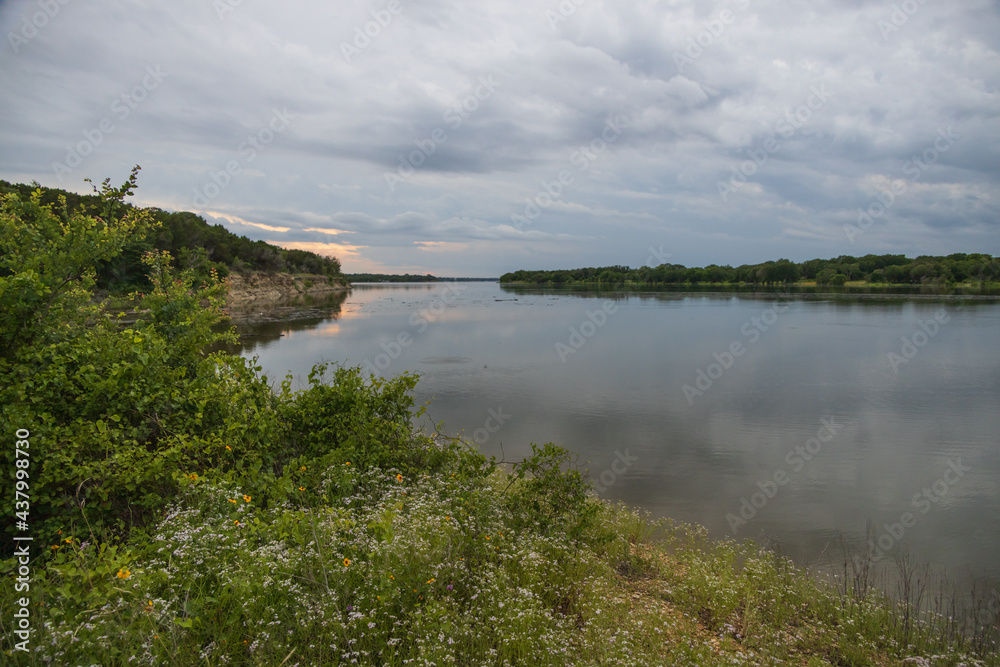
[0,168,250,552]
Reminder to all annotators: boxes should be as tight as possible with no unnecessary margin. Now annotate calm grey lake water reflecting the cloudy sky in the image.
[232,283,1000,581]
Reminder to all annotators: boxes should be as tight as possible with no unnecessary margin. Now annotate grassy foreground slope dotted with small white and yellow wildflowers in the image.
[2,436,1000,667]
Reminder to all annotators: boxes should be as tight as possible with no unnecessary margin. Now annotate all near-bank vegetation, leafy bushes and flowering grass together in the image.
[0,175,1000,667]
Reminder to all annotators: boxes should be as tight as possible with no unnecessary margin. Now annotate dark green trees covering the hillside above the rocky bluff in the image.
[0,180,341,292]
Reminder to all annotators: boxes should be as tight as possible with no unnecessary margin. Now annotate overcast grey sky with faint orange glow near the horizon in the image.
[0,0,1000,276]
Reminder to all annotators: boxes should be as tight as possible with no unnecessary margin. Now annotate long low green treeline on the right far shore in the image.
[500,253,1000,285]
